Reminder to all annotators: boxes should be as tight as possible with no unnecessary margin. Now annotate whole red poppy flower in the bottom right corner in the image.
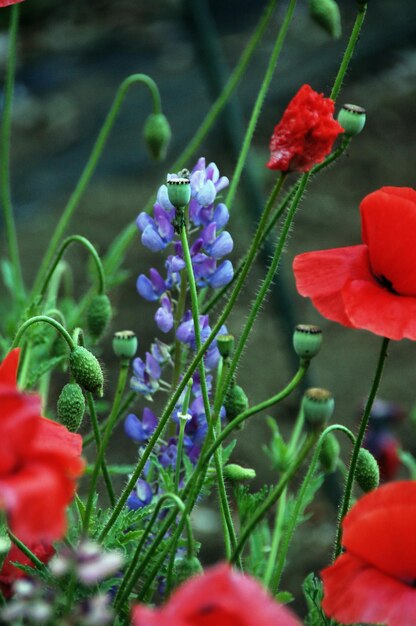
[321,481,416,626]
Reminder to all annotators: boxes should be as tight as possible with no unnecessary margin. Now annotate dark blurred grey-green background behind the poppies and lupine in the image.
[0,0,416,608]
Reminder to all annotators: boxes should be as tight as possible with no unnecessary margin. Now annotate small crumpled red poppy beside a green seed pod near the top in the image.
[267,85,344,172]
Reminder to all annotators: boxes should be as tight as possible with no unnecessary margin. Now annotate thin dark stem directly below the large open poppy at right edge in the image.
[334,337,390,560]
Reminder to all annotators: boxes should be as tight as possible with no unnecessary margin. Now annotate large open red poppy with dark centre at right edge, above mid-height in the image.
[293,187,416,339]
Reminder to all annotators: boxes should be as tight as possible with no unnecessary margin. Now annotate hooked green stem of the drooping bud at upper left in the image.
[32,74,161,298]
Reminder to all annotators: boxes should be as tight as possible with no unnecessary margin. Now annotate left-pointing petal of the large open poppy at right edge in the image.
[293,245,371,327]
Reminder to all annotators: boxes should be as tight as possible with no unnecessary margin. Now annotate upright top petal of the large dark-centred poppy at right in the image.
[360,187,416,296]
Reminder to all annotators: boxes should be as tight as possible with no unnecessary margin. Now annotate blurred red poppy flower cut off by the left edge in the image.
[0,349,83,544]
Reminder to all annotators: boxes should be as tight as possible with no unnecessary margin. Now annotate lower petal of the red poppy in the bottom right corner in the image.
[321,554,416,626]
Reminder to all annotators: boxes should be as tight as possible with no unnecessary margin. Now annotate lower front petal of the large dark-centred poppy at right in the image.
[342,280,416,339]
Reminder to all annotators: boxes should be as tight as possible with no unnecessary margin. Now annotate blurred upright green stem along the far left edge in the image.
[0,4,25,300]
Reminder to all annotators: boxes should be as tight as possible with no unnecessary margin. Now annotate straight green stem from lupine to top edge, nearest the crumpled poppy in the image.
[225,0,296,209]
